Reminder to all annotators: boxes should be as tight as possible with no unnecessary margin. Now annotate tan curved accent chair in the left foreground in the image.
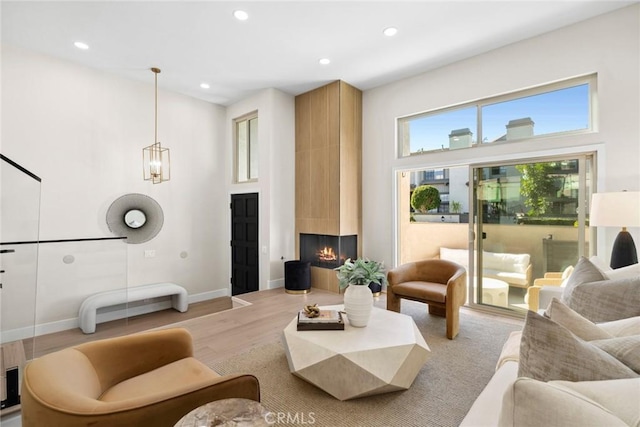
[21,328,260,427]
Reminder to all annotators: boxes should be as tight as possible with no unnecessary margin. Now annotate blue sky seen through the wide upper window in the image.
[410,84,589,152]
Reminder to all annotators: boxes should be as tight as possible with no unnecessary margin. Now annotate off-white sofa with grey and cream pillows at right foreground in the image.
[461,258,640,427]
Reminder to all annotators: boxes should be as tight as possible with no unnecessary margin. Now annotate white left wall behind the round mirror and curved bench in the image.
[2,45,229,338]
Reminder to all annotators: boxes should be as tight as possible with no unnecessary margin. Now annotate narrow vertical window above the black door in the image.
[234,113,258,182]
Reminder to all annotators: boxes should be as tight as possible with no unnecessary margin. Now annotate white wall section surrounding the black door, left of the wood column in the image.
[225,89,295,290]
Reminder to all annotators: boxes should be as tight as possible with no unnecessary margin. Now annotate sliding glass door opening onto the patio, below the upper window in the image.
[396,154,595,312]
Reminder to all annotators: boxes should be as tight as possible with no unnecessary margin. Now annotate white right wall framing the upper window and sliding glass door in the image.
[363,4,640,266]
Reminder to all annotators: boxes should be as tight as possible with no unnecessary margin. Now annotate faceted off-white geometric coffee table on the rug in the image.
[283,305,431,400]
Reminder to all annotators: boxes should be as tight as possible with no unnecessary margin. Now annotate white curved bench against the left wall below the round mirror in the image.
[78,283,189,334]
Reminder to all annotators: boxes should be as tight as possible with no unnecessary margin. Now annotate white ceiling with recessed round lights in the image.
[0,0,637,105]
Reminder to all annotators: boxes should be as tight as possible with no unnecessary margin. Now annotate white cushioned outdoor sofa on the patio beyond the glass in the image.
[440,248,532,288]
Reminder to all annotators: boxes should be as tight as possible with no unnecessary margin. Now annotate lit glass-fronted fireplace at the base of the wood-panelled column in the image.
[300,233,358,268]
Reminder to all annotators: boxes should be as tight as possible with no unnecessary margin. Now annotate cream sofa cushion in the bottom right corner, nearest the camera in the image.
[498,378,640,427]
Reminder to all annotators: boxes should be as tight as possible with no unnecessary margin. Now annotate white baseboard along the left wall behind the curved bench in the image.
[0,289,232,343]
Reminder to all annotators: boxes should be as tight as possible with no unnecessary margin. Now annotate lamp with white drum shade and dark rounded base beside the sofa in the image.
[589,191,640,268]
